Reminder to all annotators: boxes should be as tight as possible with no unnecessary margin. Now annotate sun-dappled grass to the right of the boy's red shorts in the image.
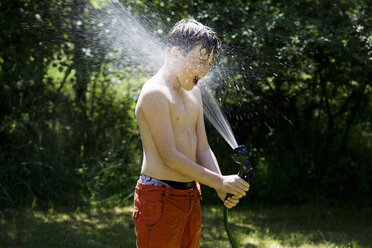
[202,203,372,248]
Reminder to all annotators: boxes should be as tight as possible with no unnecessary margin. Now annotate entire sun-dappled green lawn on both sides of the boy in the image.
[0,202,372,248]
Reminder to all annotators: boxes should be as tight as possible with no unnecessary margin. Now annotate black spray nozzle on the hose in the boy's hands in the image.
[232,145,254,182]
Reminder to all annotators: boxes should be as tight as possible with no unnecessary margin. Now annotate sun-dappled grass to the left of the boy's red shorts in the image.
[0,205,135,248]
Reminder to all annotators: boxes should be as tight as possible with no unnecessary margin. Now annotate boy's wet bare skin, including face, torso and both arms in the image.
[136,45,249,208]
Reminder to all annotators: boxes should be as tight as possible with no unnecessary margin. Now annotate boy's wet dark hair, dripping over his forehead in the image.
[167,19,222,57]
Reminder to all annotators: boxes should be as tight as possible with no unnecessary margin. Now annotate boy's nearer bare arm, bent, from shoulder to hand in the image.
[140,89,245,198]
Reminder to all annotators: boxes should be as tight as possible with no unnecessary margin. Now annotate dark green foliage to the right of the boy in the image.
[175,1,372,204]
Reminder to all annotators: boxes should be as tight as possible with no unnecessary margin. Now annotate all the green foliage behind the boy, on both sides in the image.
[0,0,372,207]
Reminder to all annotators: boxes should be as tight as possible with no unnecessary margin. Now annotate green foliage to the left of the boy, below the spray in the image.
[0,1,143,207]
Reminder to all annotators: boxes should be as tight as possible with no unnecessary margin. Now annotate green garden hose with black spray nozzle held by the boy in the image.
[223,145,254,248]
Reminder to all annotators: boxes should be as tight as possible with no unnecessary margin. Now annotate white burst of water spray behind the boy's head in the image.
[88,0,165,74]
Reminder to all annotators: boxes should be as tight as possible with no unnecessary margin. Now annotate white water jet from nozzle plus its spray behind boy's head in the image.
[93,1,238,149]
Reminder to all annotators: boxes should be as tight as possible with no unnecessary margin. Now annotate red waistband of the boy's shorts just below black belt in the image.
[136,181,202,199]
